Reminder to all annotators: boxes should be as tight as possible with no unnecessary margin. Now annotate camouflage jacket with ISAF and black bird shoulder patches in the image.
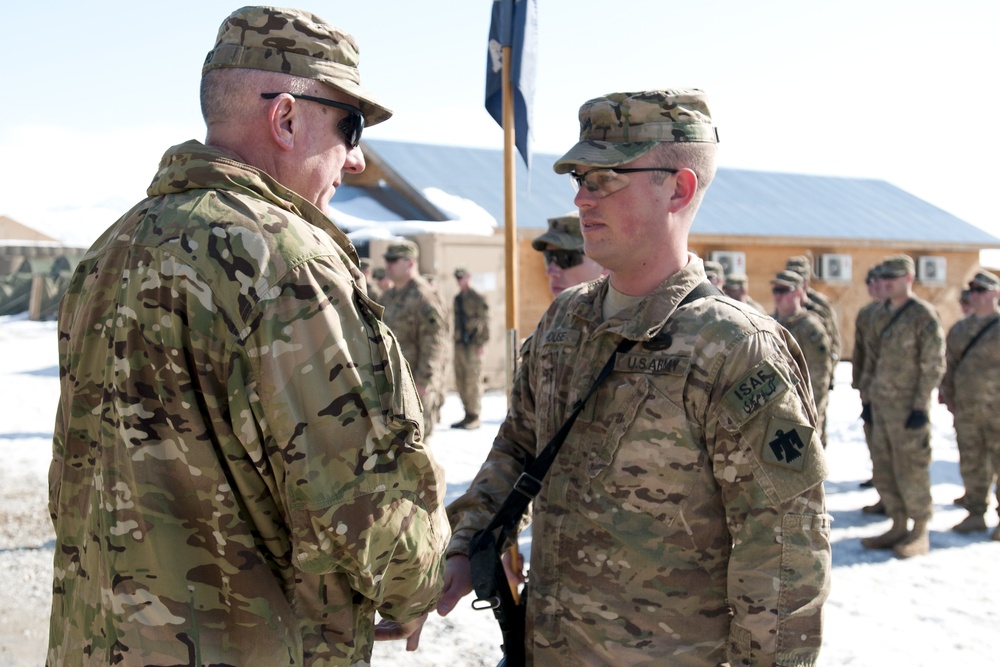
[448,258,830,667]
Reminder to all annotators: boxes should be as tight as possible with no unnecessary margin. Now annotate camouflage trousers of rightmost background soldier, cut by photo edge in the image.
[955,411,1000,514]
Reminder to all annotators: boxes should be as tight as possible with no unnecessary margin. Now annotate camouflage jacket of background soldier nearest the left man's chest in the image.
[382,276,449,391]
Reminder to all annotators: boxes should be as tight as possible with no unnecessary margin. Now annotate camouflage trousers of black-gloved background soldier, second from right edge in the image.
[872,403,934,519]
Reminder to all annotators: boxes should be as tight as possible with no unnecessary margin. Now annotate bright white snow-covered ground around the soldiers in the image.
[0,318,1000,667]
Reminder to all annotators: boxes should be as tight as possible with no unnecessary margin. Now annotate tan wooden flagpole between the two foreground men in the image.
[501,41,521,602]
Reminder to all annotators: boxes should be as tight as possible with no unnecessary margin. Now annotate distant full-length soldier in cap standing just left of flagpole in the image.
[451,268,490,429]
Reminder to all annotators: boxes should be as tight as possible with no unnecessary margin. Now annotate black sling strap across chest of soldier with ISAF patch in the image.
[470,282,722,549]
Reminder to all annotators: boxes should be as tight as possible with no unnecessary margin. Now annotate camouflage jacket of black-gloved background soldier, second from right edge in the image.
[861,297,944,412]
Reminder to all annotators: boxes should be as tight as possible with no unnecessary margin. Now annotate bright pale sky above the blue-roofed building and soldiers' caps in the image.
[0,0,1000,249]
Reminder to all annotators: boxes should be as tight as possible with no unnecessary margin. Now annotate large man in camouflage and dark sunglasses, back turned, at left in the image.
[47,7,449,666]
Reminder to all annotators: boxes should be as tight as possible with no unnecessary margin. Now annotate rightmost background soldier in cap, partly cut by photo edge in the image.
[939,271,1000,540]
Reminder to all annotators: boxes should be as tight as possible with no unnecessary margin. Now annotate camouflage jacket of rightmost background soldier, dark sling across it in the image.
[940,312,1000,419]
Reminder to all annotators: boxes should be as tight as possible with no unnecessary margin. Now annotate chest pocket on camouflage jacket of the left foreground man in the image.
[354,286,423,429]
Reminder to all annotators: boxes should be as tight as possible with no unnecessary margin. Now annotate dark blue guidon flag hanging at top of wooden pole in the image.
[486,0,538,168]
